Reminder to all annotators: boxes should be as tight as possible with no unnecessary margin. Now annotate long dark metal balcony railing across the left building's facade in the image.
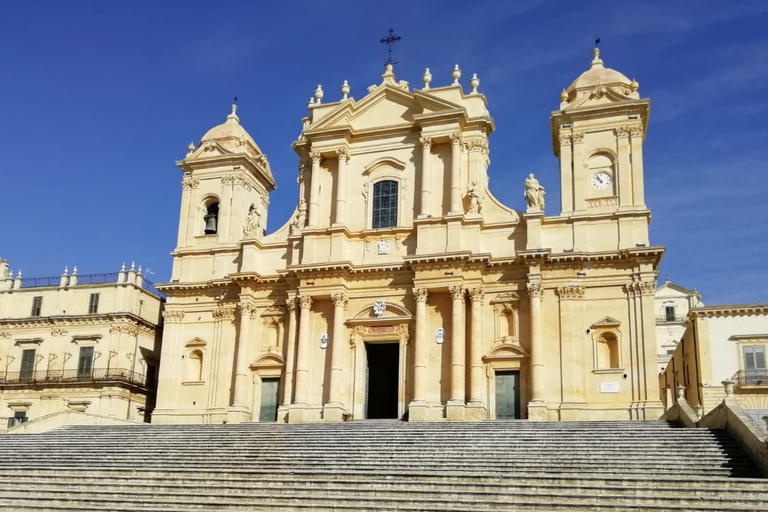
[0,368,155,389]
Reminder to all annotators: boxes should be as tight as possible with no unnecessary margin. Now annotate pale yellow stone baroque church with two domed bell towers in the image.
[152,49,664,423]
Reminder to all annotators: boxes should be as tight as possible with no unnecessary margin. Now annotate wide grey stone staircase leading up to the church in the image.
[0,421,768,512]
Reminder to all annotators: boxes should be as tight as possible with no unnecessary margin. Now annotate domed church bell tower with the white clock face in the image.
[550,48,650,216]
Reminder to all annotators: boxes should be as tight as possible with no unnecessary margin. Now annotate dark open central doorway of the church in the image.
[365,343,400,419]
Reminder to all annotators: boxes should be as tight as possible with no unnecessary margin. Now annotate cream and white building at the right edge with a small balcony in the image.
[660,304,768,425]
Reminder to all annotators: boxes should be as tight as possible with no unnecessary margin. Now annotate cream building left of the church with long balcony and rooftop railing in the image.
[0,259,163,428]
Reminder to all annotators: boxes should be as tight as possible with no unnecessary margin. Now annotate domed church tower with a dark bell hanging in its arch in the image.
[173,105,276,282]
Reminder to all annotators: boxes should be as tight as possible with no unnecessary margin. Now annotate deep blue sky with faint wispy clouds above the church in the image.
[0,0,768,304]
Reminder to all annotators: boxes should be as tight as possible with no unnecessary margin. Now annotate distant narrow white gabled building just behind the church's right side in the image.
[655,278,704,373]
